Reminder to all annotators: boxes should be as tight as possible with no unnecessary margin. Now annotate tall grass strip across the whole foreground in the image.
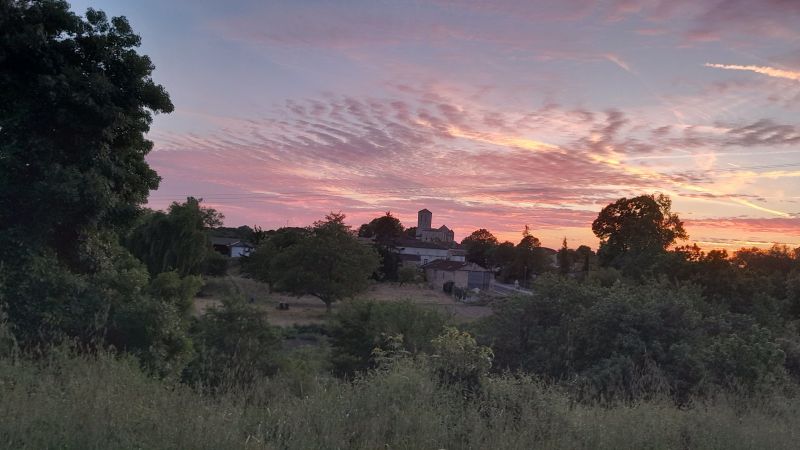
[0,351,800,449]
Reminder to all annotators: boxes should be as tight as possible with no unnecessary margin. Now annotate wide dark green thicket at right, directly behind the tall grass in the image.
[478,277,784,402]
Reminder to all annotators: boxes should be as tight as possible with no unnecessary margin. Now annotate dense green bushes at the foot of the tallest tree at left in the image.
[3,241,197,376]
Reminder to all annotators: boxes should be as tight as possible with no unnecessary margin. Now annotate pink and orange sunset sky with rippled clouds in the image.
[71,0,800,249]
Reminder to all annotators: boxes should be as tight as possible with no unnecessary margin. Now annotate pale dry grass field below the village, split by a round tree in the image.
[195,268,491,326]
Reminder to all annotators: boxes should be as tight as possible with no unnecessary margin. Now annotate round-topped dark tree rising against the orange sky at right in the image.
[592,194,688,268]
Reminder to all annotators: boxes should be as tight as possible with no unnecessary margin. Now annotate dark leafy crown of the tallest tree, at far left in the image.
[0,0,173,268]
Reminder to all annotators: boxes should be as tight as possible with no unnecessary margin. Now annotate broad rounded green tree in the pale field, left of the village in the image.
[269,213,379,311]
